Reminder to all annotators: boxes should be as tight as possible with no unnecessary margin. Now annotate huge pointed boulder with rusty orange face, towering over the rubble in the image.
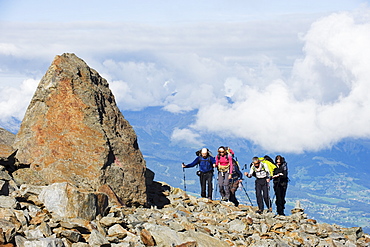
[13,53,147,205]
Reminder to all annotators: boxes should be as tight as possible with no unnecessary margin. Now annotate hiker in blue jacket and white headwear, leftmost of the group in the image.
[182,148,216,200]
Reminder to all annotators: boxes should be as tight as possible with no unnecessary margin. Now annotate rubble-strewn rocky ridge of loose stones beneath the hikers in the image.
[0,166,370,247]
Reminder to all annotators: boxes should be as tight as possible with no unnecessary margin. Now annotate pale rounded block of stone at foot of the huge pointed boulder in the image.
[39,182,104,220]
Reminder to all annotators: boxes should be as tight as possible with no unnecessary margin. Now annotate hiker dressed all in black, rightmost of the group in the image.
[272,155,288,215]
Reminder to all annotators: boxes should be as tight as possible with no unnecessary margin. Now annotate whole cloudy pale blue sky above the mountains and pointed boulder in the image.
[0,0,370,153]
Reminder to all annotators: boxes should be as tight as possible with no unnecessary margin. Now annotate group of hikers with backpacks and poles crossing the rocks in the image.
[182,146,288,215]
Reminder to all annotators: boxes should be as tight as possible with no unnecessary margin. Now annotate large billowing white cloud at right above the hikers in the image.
[192,11,370,152]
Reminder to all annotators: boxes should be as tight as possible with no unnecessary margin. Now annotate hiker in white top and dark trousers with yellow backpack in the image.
[244,157,271,214]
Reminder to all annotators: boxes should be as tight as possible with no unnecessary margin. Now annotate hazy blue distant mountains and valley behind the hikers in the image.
[0,107,370,233]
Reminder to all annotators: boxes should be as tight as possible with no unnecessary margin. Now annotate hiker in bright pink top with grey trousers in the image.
[215,146,233,201]
